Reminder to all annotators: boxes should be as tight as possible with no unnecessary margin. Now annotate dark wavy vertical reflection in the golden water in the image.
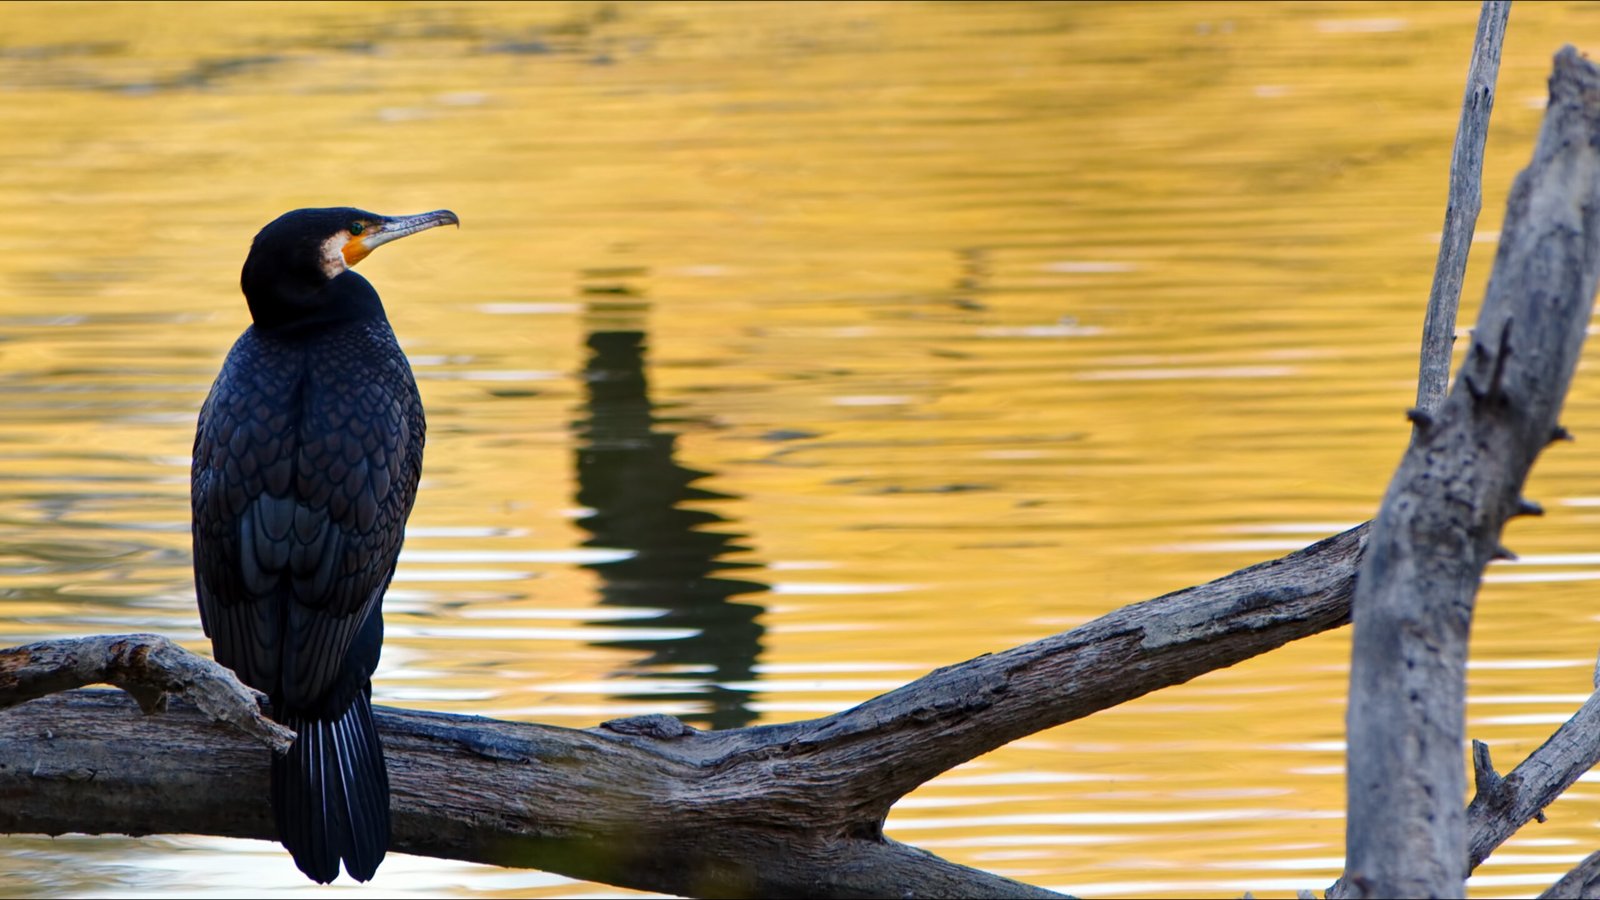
[574,301,768,729]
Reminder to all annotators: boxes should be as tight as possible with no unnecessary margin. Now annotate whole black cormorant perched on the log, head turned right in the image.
[190,208,461,884]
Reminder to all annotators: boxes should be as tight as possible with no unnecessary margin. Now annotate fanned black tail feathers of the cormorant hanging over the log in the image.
[272,692,389,884]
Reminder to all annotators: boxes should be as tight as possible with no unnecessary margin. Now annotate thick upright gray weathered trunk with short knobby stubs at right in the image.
[1346,46,1600,897]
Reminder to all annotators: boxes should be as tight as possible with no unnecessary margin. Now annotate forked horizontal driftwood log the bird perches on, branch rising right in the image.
[0,525,1366,897]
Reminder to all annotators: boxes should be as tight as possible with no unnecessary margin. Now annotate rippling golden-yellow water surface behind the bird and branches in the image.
[0,3,1600,897]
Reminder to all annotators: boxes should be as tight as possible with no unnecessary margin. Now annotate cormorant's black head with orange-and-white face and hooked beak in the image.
[238,207,461,328]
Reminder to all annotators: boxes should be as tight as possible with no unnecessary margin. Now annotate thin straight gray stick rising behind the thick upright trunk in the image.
[1416,0,1510,413]
